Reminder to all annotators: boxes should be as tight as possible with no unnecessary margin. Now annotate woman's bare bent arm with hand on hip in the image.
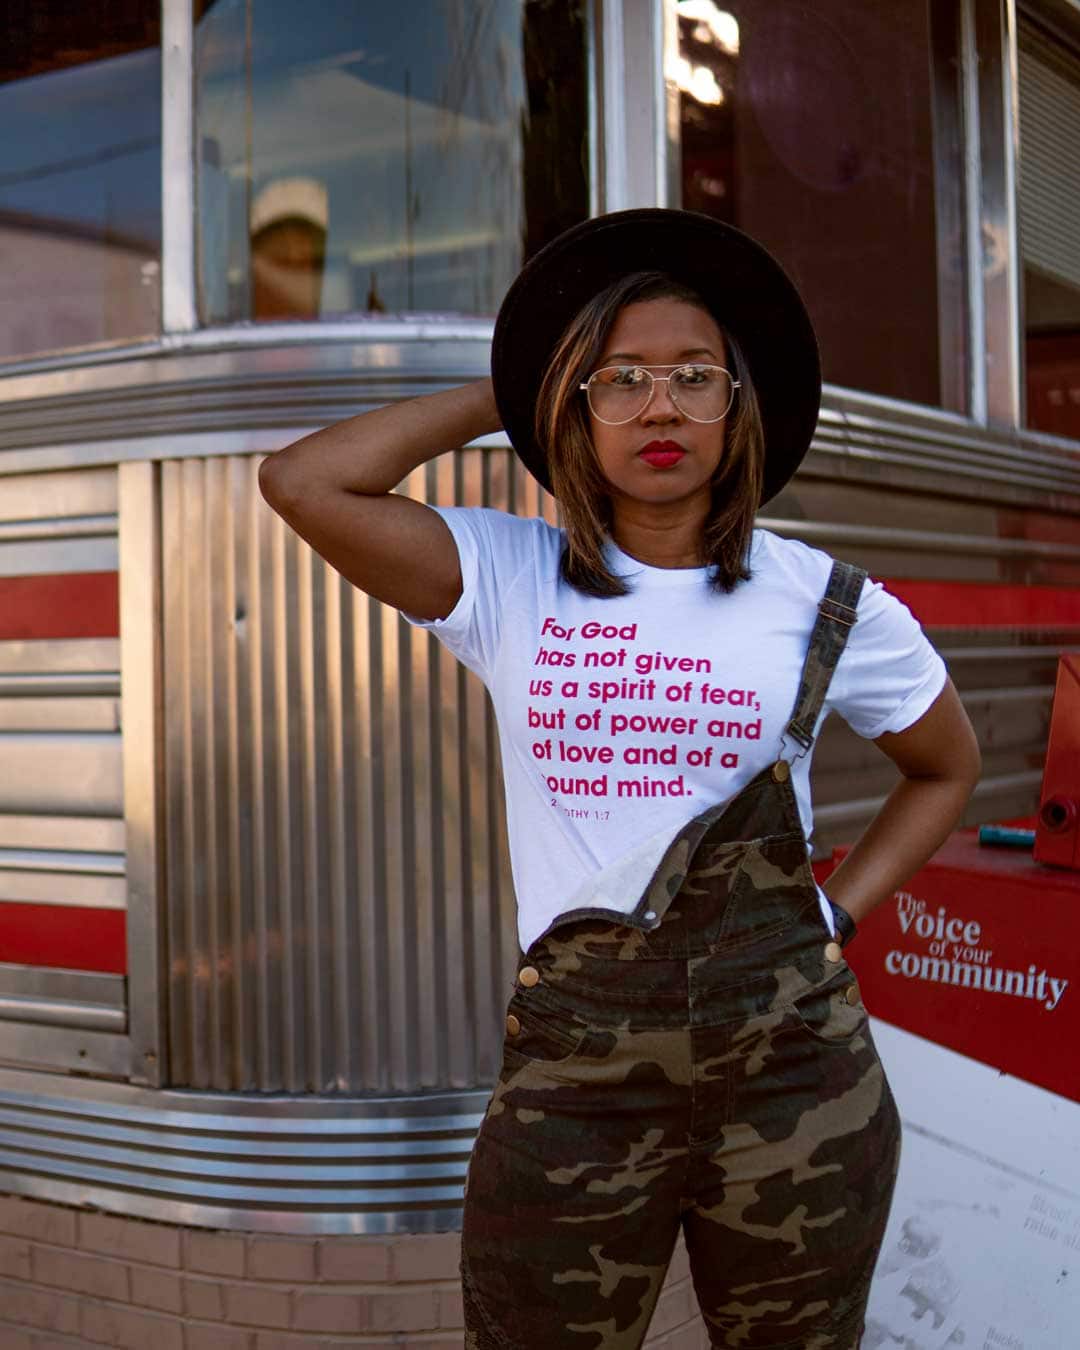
[825,680,980,923]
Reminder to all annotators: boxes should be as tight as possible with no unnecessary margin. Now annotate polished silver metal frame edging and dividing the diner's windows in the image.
[0,0,1080,447]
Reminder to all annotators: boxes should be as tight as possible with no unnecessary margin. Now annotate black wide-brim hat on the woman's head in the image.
[491,208,821,502]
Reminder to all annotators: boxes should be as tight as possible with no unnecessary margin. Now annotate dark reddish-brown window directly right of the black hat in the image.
[675,0,968,412]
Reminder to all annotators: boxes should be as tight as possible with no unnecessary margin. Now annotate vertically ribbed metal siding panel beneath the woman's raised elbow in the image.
[162,450,556,1092]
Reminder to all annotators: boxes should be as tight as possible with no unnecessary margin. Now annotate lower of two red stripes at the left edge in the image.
[0,902,127,975]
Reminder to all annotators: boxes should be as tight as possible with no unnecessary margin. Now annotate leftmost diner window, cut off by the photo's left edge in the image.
[0,0,161,359]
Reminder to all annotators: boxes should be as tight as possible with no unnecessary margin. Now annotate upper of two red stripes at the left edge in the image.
[0,572,120,640]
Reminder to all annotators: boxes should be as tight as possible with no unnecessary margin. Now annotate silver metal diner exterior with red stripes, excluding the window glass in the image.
[0,0,1080,1233]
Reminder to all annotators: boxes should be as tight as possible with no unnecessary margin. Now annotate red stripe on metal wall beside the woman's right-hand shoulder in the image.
[882,576,1080,628]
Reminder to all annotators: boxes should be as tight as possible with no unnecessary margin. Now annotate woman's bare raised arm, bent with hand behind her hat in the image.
[259,379,500,618]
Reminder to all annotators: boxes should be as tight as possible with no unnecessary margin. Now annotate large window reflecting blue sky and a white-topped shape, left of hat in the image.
[194,0,589,323]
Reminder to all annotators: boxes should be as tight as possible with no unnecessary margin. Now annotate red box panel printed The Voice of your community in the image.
[829,830,1080,1102]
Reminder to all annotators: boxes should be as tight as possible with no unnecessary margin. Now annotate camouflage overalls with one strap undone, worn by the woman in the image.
[462,564,899,1350]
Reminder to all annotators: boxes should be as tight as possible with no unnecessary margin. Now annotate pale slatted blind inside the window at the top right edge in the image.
[1018,34,1080,286]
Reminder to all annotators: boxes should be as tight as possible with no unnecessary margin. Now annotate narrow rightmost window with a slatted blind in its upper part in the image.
[1018,19,1080,440]
